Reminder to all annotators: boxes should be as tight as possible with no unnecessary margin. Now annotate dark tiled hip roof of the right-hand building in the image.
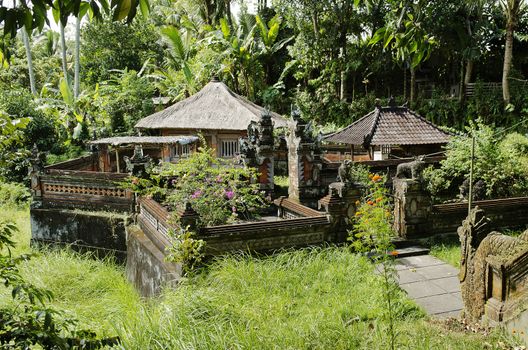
[324,106,451,148]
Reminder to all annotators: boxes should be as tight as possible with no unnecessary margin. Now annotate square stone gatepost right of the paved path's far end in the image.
[393,178,432,238]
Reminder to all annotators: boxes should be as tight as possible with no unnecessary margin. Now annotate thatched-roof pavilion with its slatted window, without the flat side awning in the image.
[135,79,287,158]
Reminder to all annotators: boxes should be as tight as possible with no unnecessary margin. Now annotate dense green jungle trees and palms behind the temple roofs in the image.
[0,0,528,181]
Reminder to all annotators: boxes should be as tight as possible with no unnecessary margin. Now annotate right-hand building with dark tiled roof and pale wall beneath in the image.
[323,101,451,160]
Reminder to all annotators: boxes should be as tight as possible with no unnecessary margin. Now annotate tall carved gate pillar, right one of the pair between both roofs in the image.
[287,110,326,208]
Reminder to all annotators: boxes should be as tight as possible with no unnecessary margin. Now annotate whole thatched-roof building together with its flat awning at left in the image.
[91,79,287,172]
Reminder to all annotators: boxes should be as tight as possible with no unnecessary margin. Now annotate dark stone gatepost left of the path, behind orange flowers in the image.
[318,182,361,242]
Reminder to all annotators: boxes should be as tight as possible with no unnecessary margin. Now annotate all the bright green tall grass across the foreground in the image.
[0,210,513,349]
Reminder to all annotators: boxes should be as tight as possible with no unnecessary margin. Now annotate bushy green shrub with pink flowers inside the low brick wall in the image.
[123,147,266,227]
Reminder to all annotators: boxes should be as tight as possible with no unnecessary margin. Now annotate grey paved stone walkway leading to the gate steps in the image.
[396,255,463,318]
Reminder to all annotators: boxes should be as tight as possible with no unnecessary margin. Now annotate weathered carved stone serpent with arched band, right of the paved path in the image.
[457,207,528,322]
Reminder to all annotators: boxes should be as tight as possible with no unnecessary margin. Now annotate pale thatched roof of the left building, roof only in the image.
[136,80,286,131]
